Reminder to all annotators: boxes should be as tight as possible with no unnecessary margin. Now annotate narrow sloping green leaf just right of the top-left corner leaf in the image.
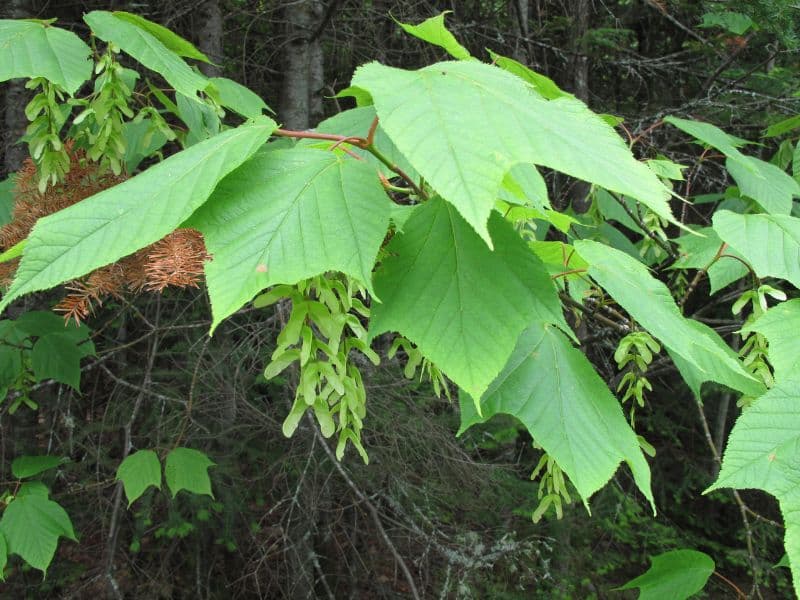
[83,10,208,98]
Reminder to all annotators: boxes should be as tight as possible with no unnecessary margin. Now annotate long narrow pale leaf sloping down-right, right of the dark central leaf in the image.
[575,240,763,396]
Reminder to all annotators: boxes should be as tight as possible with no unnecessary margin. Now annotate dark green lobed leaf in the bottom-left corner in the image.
[0,494,78,572]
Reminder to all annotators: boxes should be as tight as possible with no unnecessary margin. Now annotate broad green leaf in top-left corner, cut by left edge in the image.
[0,19,92,95]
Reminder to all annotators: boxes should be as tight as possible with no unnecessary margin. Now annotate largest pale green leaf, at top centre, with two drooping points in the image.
[353,61,672,243]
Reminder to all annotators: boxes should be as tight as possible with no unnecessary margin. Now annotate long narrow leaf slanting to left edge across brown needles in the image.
[0,117,276,311]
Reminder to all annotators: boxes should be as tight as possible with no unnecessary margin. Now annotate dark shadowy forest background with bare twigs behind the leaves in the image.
[0,0,800,599]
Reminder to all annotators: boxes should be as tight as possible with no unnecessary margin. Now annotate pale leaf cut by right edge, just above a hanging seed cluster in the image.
[713,210,800,287]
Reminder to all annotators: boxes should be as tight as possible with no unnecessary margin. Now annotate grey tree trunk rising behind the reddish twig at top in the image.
[280,0,325,130]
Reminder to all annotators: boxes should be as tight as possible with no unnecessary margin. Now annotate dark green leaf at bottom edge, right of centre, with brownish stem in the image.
[617,550,714,600]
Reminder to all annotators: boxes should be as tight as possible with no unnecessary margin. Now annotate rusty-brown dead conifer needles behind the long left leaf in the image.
[0,141,211,323]
